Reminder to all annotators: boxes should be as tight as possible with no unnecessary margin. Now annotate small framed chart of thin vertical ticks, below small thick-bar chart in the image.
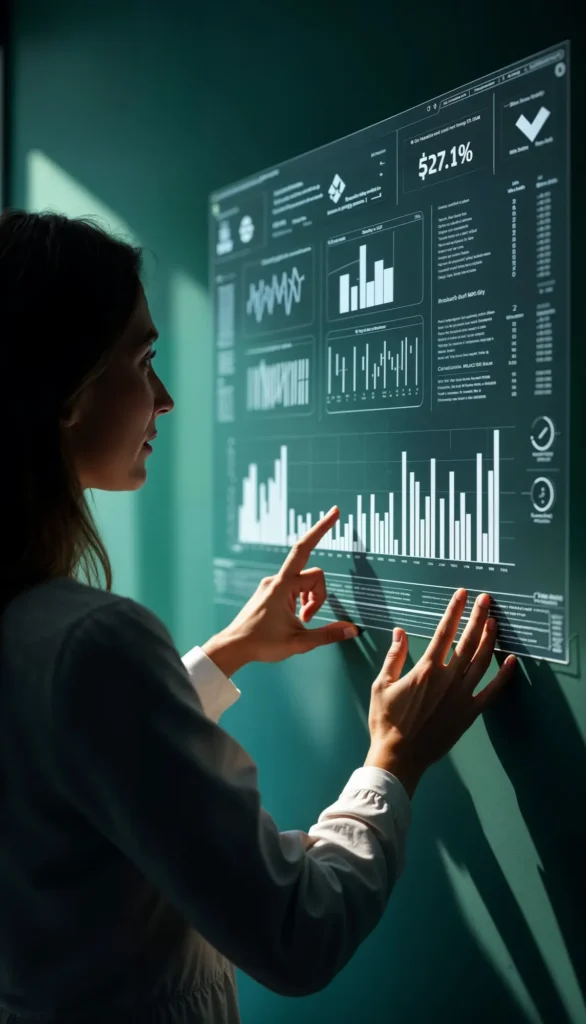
[326,319,423,413]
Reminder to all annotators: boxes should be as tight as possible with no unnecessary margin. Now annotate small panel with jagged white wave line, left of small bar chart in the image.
[244,246,313,335]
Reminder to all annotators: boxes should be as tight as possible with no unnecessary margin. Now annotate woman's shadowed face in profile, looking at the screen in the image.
[67,289,173,490]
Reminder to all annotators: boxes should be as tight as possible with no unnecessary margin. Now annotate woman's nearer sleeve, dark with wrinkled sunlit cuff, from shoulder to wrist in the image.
[51,598,410,995]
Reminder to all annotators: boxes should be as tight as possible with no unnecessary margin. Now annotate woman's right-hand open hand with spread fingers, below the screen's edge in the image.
[366,590,516,796]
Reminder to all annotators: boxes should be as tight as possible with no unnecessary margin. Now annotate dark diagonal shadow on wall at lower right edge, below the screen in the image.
[485,654,586,996]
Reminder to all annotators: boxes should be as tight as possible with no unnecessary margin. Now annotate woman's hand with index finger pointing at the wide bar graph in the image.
[203,506,359,676]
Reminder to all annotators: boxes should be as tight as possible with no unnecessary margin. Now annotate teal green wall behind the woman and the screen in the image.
[6,0,586,1024]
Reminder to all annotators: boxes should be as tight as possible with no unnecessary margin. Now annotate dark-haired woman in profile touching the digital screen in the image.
[0,212,514,1024]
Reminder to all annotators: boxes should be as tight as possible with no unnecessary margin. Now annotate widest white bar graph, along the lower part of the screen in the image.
[238,429,511,565]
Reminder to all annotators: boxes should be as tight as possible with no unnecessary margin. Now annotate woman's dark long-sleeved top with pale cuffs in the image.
[0,580,410,1024]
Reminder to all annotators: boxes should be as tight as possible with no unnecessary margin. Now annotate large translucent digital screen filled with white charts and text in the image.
[209,43,570,662]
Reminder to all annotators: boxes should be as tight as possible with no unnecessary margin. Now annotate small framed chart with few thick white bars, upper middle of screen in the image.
[327,214,423,319]
